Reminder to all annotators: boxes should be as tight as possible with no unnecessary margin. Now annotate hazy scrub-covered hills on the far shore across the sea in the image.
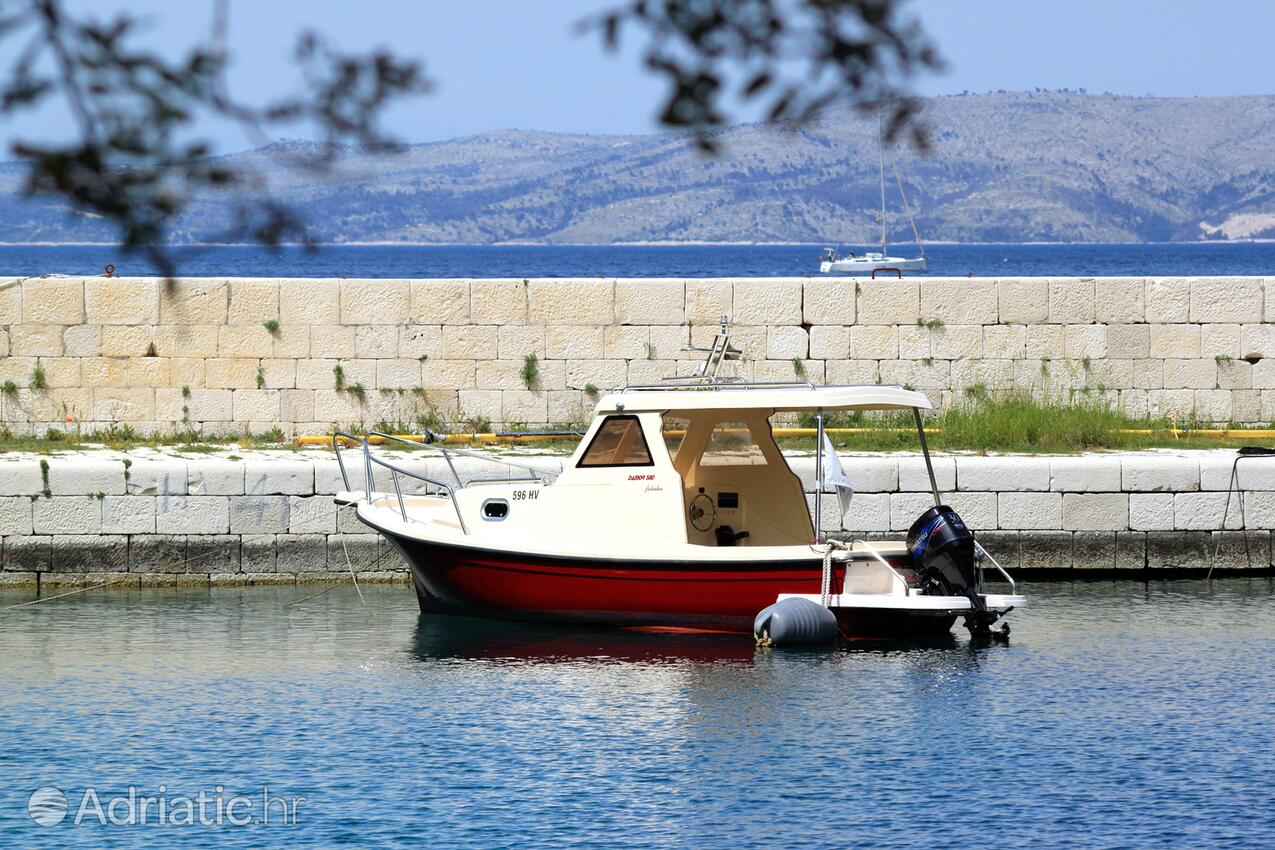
[0,92,1275,243]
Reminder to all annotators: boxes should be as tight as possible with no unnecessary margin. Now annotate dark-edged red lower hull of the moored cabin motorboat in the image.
[383,531,954,636]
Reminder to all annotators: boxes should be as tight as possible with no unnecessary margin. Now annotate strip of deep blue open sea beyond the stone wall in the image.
[0,243,1275,278]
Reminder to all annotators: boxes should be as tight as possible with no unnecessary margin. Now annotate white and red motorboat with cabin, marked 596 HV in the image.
[333,322,1025,637]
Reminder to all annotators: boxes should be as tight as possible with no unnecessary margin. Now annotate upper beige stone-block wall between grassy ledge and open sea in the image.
[0,277,1275,436]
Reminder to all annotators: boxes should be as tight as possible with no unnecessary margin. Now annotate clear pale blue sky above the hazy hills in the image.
[7,0,1275,152]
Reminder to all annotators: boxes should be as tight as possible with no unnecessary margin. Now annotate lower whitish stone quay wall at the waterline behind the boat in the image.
[0,451,1275,585]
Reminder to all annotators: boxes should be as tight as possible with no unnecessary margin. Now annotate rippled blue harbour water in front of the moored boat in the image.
[0,580,1275,850]
